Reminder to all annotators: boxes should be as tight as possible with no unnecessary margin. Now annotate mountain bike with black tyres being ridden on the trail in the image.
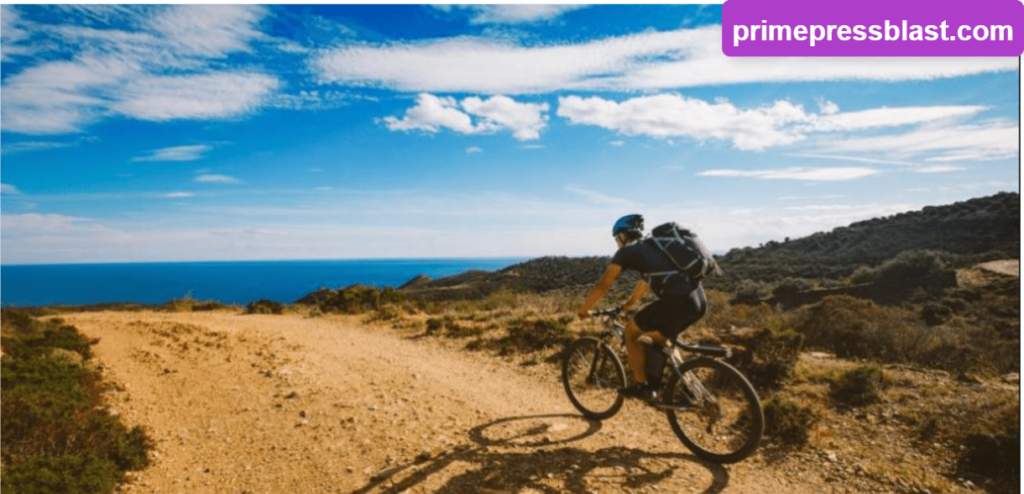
[562,308,765,463]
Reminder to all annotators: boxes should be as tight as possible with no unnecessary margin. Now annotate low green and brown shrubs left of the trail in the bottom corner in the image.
[0,308,153,494]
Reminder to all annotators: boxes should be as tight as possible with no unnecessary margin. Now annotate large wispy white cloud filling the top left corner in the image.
[0,4,280,134]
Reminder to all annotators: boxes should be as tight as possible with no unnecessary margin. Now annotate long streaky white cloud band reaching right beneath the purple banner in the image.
[310,26,1017,94]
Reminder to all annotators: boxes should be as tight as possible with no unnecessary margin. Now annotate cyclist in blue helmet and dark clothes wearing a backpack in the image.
[578,214,708,401]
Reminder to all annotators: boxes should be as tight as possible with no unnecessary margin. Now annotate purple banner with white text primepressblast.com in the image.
[722,0,1024,56]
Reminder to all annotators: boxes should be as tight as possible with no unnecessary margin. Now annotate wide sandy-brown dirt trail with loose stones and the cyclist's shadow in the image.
[54,312,831,494]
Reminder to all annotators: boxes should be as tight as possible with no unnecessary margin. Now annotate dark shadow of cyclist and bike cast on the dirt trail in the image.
[352,414,729,494]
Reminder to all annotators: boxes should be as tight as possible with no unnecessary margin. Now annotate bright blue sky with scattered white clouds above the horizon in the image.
[0,4,1020,264]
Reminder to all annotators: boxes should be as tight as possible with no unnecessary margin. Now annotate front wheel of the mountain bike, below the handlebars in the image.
[562,337,626,420]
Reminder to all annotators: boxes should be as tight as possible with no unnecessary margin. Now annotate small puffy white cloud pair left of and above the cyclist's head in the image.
[383,93,548,140]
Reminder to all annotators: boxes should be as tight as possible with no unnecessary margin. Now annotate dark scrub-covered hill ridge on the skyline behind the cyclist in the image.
[401,193,1020,300]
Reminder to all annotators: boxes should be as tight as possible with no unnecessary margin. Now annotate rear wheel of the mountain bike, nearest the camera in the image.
[666,358,765,463]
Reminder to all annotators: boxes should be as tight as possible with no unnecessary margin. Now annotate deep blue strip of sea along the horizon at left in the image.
[0,258,526,306]
